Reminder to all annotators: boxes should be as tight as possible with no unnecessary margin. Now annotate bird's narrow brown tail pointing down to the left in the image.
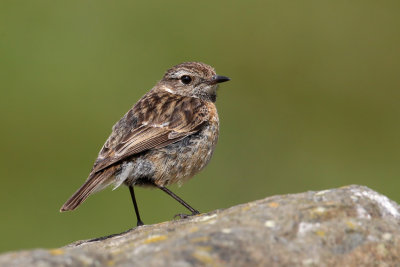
[60,169,113,212]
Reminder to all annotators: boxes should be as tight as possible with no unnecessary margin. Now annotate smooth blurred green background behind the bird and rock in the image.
[0,0,400,254]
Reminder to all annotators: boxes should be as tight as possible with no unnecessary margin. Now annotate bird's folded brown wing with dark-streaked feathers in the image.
[91,92,209,174]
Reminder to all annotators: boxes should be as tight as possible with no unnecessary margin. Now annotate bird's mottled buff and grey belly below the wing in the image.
[119,121,219,187]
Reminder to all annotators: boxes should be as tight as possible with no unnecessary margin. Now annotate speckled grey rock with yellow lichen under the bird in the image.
[0,186,400,267]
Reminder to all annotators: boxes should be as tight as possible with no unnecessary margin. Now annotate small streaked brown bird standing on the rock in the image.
[60,62,230,226]
